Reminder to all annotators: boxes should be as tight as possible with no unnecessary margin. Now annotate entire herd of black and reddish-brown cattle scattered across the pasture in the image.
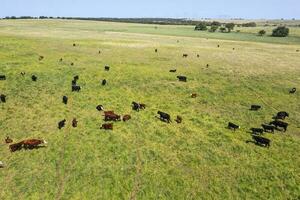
[0,44,296,168]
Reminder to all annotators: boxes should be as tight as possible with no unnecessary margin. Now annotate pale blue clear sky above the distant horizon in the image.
[0,0,300,19]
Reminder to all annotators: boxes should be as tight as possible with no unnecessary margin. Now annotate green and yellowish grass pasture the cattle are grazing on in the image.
[0,20,300,200]
